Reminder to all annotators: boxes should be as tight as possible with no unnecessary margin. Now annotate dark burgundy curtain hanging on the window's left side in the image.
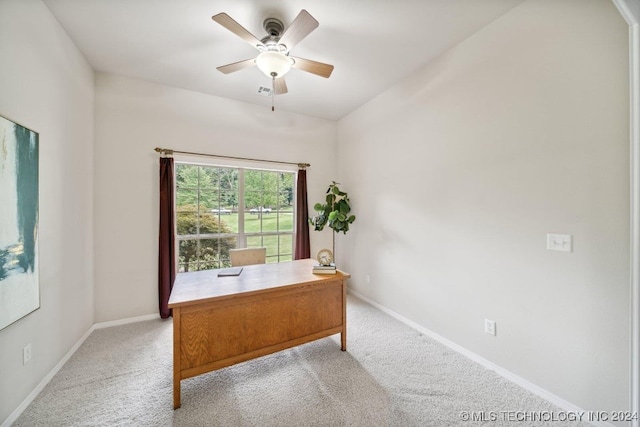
[158,157,176,319]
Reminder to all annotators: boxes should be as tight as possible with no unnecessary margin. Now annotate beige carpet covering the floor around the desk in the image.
[14,296,583,427]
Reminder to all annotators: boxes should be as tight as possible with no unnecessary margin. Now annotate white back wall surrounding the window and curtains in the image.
[95,74,337,322]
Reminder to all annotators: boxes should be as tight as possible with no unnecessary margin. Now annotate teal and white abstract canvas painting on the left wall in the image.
[0,116,40,329]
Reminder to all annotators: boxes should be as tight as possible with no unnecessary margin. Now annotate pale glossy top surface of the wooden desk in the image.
[169,259,350,307]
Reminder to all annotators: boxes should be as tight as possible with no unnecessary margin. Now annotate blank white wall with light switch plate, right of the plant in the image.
[338,0,630,418]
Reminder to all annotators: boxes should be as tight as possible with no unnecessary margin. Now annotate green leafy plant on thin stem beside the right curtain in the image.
[309,181,356,260]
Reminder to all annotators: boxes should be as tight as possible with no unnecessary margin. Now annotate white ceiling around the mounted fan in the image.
[44,0,524,120]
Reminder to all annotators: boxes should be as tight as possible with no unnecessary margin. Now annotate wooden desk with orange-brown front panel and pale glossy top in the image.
[169,259,350,409]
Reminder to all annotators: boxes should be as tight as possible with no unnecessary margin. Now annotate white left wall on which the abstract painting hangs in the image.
[0,0,93,422]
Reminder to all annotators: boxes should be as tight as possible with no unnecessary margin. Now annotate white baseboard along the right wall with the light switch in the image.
[348,289,614,427]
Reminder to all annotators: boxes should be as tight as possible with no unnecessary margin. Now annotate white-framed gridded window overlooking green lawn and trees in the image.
[175,163,295,272]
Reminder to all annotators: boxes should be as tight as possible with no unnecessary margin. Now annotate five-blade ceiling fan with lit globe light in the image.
[211,9,333,101]
